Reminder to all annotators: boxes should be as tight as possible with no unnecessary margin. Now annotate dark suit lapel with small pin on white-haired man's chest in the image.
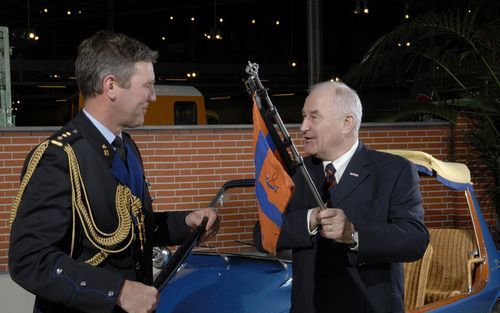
[330,142,371,207]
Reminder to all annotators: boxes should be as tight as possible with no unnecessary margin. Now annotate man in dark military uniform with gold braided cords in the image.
[9,31,219,313]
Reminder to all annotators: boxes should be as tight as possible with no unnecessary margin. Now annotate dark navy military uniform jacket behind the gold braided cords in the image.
[9,112,193,313]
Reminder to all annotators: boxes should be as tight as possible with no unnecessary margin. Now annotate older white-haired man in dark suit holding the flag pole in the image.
[254,82,429,313]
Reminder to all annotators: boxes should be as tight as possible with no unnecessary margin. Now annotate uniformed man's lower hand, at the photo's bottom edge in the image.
[117,280,160,313]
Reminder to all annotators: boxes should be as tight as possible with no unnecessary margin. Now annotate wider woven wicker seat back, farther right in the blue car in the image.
[425,228,477,304]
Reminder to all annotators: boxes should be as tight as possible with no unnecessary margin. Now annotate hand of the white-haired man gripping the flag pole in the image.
[311,208,355,244]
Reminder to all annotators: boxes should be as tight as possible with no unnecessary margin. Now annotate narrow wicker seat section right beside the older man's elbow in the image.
[403,244,433,311]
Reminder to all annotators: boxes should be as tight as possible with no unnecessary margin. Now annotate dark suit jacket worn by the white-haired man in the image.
[254,143,429,313]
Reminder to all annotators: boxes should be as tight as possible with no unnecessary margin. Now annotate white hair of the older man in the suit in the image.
[309,81,363,133]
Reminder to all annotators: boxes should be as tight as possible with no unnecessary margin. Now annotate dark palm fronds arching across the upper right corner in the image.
[346,6,500,87]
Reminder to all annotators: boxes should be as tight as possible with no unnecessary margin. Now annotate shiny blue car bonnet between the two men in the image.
[157,253,292,313]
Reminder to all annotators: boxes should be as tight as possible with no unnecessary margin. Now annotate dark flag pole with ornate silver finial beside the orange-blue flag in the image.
[245,61,326,210]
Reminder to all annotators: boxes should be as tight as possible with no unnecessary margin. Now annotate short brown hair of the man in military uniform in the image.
[75,31,158,98]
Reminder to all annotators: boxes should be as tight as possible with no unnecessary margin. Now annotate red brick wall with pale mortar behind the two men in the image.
[0,123,493,272]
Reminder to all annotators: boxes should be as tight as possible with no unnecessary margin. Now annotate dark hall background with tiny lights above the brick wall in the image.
[0,0,454,126]
